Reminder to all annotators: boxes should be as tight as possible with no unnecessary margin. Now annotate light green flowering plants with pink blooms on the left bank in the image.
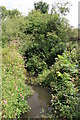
[2,47,31,118]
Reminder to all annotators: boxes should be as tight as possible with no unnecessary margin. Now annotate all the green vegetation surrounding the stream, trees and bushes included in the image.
[2,2,80,120]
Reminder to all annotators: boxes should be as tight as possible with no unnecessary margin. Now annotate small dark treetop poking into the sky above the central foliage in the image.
[34,1,49,14]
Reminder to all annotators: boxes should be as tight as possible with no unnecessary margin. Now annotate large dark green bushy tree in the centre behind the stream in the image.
[21,11,72,75]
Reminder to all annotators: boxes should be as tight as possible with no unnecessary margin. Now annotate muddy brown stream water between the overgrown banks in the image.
[22,86,51,118]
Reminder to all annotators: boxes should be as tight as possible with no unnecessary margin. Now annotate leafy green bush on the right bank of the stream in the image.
[37,49,80,119]
